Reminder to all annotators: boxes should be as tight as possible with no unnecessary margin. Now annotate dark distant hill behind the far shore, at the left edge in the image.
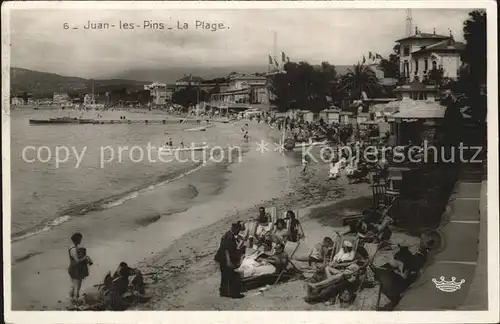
[10,67,148,97]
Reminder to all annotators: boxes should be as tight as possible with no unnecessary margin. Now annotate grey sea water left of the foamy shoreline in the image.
[11,110,239,240]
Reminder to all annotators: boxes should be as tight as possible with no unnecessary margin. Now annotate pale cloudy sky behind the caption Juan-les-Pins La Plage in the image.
[10,8,476,78]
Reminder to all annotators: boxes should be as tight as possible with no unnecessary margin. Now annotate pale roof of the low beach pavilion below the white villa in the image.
[391,99,446,119]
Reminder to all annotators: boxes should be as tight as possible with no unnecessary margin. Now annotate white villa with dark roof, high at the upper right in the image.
[396,28,465,82]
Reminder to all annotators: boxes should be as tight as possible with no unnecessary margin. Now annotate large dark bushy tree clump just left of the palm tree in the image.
[269,62,337,112]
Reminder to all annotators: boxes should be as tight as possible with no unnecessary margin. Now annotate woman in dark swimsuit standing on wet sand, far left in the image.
[68,233,92,303]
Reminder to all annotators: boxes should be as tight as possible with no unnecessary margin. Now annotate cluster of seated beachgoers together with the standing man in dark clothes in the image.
[214,207,304,298]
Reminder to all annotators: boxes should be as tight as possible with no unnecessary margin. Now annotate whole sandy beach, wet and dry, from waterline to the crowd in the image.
[12,114,418,310]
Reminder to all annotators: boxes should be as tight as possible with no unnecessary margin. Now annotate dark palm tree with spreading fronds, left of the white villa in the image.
[340,63,380,99]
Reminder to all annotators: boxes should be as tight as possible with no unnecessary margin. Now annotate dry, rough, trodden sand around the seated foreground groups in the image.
[127,125,419,310]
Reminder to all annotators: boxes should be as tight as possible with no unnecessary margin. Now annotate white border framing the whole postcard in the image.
[1,0,500,324]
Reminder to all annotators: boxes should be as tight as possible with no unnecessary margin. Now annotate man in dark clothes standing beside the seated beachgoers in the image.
[214,223,244,298]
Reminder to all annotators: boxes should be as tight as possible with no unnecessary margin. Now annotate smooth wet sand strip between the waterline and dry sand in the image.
[12,124,287,310]
